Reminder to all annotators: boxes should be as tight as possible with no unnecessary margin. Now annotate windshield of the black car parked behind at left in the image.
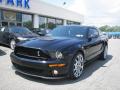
[10,27,32,34]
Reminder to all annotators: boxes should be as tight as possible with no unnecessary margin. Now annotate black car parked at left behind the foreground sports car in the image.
[0,27,38,49]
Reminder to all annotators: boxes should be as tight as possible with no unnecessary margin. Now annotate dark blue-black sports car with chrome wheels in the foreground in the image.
[11,26,108,79]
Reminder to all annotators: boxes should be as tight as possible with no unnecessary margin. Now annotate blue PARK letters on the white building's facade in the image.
[0,0,30,9]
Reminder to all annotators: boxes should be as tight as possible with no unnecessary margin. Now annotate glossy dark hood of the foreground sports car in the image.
[17,37,84,51]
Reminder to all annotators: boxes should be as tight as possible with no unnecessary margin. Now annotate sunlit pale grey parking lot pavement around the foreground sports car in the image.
[0,39,120,90]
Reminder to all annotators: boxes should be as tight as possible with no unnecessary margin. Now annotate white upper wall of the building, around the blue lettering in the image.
[0,0,84,22]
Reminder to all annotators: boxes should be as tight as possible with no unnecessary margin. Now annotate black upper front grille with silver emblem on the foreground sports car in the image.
[15,46,50,60]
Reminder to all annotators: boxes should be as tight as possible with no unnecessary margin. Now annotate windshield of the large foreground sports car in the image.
[49,26,87,38]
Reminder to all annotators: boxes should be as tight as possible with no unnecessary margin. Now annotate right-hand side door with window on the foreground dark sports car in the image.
[86,28,102,60]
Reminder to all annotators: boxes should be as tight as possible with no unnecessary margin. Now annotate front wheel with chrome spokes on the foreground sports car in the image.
[70,53,84,79]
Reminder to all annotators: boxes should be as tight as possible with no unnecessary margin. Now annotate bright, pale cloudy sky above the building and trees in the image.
[42,0,120,27]
